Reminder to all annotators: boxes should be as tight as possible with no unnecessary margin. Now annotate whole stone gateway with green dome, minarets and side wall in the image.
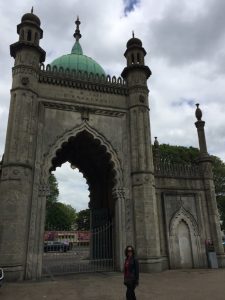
[0,12,224,280]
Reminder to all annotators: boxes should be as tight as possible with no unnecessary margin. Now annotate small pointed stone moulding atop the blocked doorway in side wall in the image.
[169,206,199,236]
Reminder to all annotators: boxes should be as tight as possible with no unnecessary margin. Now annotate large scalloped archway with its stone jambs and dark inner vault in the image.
[26,122,124,278]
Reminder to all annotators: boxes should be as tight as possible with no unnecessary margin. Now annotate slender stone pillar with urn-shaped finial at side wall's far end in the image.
[195,104,224,267]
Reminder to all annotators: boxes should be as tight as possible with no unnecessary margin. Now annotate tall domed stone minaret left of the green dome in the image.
[0,9,45,280]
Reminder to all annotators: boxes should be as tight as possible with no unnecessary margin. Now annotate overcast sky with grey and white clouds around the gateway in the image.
[0,0,225,210]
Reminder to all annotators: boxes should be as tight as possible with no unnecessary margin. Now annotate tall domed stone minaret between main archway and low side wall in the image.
[122,34,162,271]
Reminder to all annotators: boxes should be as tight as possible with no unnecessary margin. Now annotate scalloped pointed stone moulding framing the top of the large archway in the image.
[41,121,123,188]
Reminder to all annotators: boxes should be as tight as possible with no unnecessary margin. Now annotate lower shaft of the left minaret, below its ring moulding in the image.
[0,163,32,280]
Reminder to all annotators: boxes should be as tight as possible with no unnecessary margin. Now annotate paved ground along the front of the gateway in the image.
[0,269,225,300]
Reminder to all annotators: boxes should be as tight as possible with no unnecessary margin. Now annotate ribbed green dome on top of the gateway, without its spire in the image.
[50,41,106,75]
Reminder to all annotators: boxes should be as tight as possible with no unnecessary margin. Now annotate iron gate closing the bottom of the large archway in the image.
[42,221,114,276]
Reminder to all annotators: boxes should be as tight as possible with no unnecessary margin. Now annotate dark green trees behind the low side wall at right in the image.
[156,144,225,230]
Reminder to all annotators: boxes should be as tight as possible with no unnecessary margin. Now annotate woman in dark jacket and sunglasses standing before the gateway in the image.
[124,246,139,300]
